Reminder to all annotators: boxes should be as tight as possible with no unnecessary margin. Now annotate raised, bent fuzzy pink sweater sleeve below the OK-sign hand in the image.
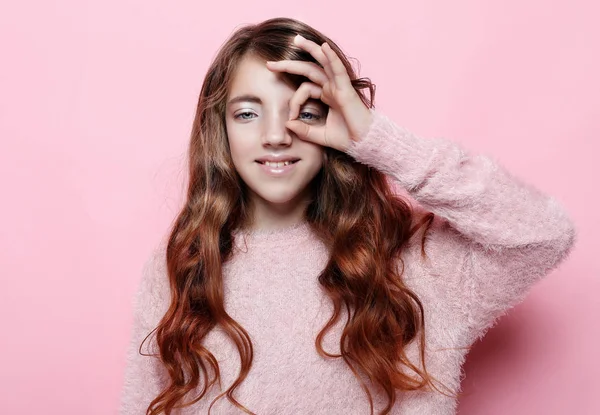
[347,109,576,341]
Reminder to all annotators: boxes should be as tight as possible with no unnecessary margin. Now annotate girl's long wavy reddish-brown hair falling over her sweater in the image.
[140,18,456,415]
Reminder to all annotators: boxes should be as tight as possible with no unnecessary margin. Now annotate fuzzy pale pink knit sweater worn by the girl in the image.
[120,110,576,415]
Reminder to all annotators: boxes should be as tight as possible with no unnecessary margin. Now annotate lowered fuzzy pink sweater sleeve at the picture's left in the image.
[119,249,170,415]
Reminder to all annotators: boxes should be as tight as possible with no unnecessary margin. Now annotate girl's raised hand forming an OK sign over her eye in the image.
[267,35,372,152]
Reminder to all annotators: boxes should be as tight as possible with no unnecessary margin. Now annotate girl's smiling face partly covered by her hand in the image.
[225,56,327,213]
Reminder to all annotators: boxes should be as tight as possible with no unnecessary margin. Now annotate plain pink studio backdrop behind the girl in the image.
[0,0,600,415]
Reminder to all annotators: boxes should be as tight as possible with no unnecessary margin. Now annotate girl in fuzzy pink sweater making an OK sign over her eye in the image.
[121,18,575,415]
